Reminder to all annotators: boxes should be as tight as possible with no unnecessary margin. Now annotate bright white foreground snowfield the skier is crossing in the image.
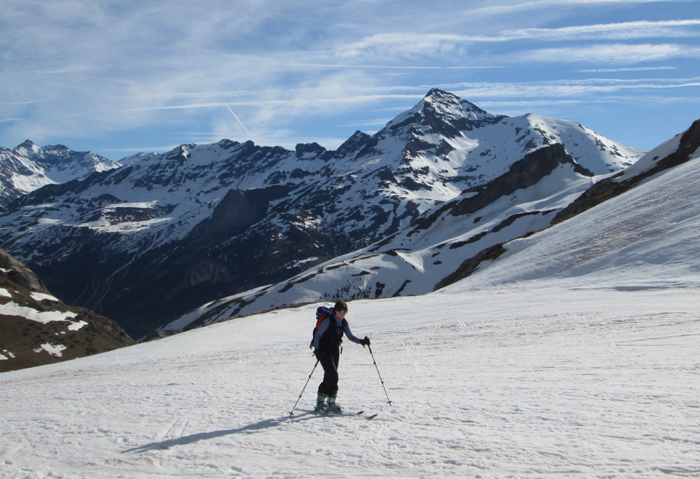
[0,287,700,479]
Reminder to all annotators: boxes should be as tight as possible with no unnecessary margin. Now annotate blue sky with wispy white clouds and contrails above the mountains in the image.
[0,0,700,160]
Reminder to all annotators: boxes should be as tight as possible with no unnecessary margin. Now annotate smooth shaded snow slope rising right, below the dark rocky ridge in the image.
[448,135,700,290]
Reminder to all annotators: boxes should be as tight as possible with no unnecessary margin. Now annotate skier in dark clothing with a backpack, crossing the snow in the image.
[314,300,370,413]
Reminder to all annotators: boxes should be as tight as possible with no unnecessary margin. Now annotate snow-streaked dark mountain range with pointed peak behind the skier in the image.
[0,89,646,337]
